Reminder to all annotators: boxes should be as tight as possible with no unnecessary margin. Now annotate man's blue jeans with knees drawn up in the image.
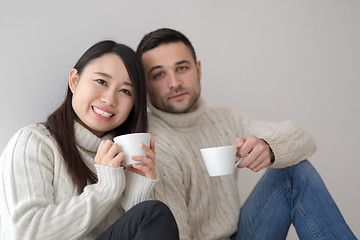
[231,160,356,240]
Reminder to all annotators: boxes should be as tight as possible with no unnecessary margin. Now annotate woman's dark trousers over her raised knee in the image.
[97,200,179,240]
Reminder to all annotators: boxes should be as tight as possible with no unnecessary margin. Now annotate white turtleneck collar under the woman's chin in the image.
[74,121,114,152]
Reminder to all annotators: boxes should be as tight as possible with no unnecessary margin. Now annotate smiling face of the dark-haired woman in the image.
[69,53,134,137]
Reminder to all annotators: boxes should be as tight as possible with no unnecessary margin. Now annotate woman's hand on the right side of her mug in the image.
[126,139,156,179]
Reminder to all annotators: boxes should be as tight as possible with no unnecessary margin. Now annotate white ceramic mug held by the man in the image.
[200,145,246,177]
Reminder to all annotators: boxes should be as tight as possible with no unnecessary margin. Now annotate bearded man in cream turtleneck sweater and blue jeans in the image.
[137,29,356,240]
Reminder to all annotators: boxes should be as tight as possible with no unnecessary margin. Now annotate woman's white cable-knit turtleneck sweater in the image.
[0,123,155,240]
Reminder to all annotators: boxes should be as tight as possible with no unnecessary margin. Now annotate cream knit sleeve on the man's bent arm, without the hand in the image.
[232,110,316,168]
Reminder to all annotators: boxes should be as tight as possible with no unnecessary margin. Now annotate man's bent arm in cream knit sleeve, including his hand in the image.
[232,111,316,171]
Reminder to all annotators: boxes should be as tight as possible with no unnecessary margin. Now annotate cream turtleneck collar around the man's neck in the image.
[148,97,206,128]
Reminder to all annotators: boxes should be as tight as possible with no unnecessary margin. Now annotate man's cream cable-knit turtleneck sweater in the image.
[148,99,315,240]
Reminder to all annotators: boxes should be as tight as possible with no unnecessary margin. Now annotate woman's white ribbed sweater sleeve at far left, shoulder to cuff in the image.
[0,128,125,239]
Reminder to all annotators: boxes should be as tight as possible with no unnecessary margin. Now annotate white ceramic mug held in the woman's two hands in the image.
[114,133,151,166]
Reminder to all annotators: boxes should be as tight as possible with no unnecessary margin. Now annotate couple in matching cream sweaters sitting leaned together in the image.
[0,29,356,239]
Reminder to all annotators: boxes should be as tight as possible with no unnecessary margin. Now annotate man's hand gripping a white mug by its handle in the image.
[235,135,274,172]
